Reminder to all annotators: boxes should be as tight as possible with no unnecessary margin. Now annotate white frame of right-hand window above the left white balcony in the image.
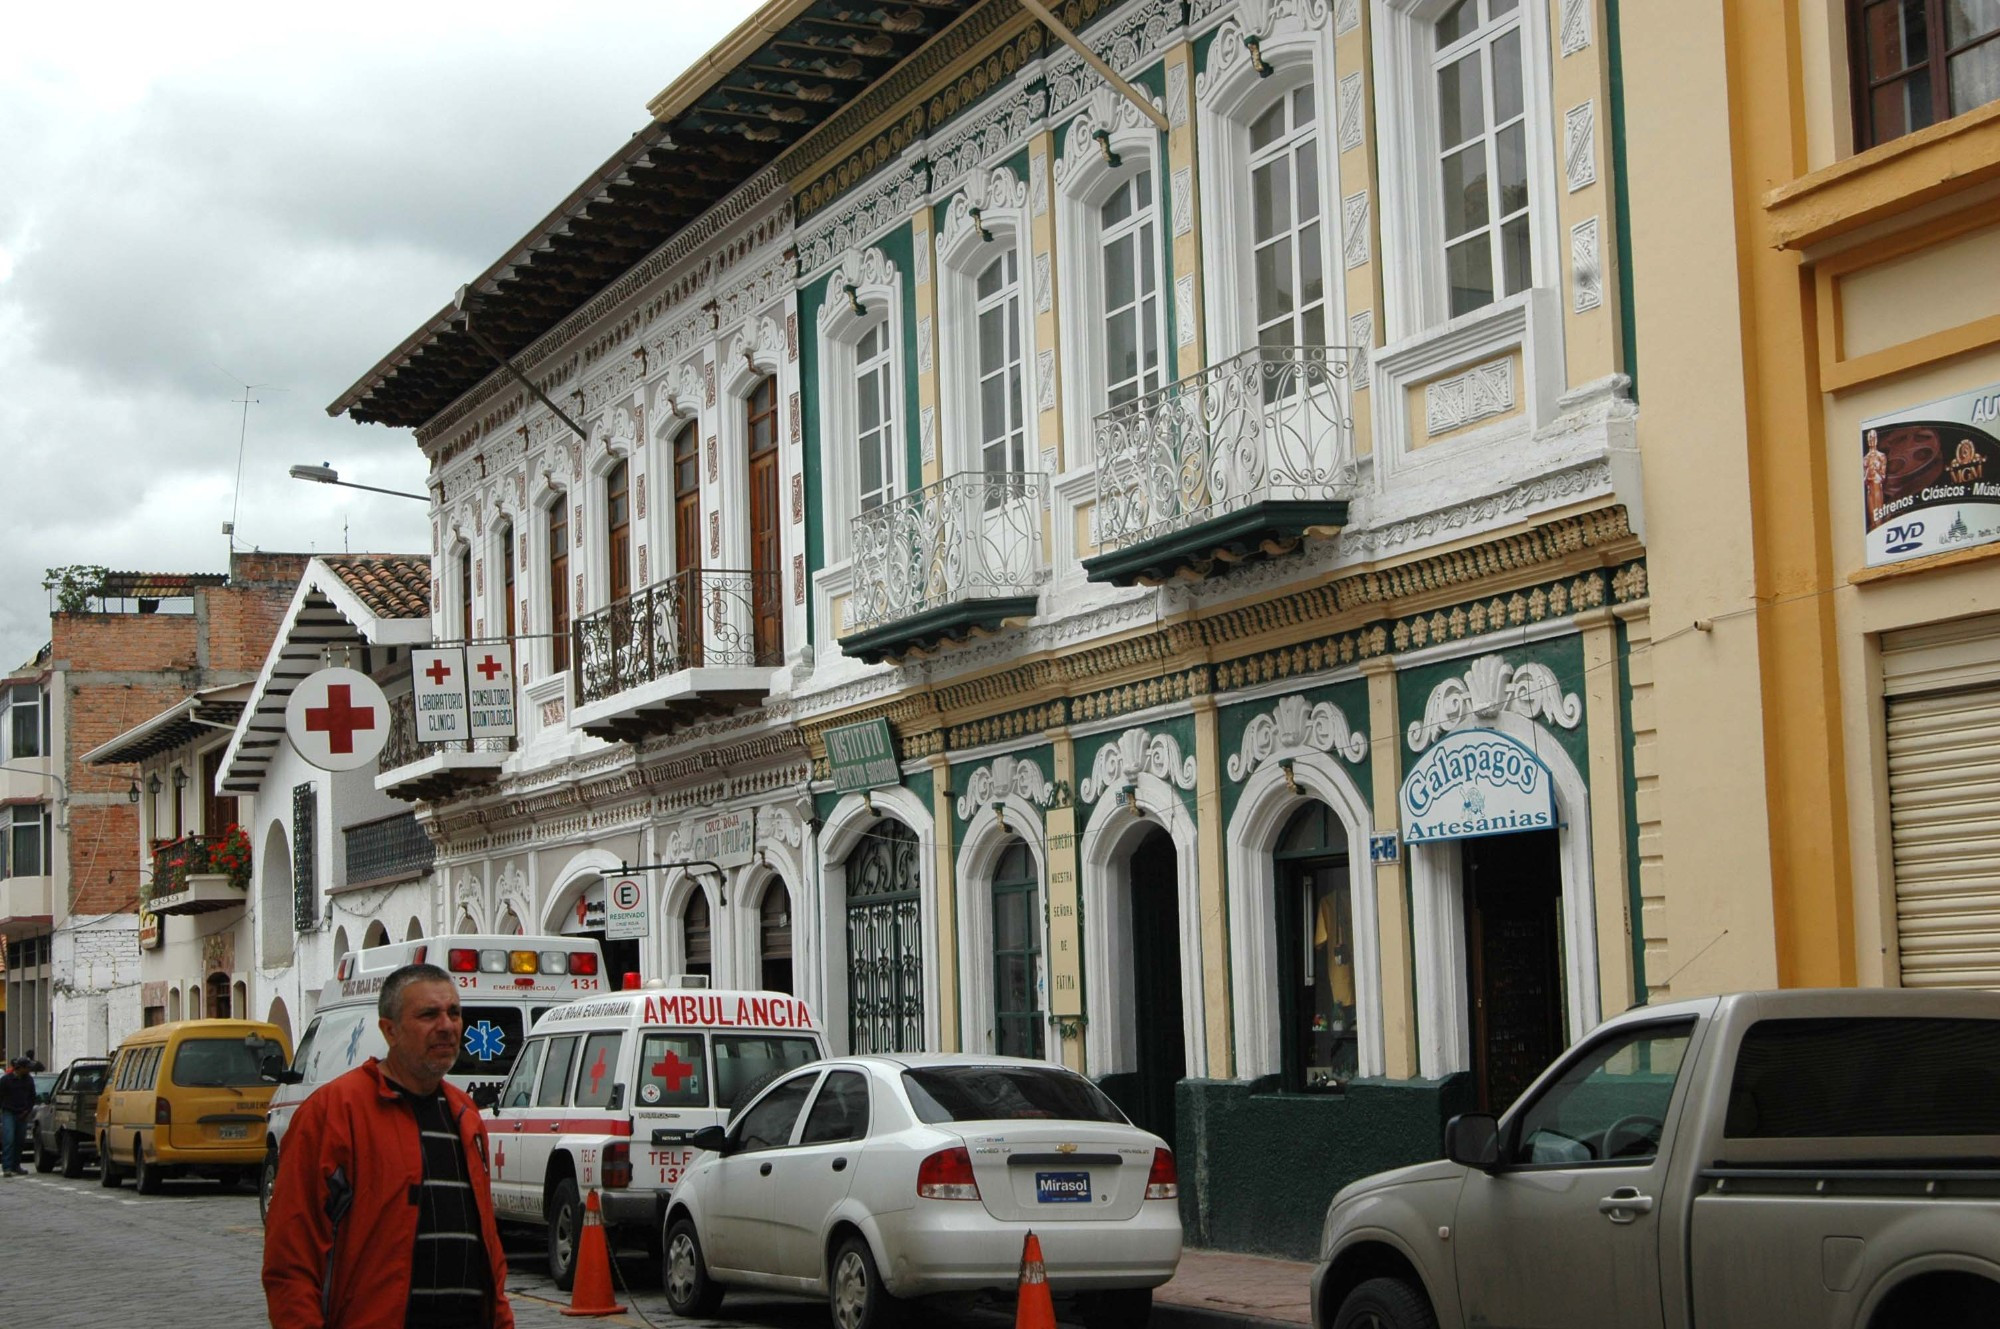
[936,166,1042,476]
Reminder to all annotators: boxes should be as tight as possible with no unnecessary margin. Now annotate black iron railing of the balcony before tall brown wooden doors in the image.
[570,568,784,707]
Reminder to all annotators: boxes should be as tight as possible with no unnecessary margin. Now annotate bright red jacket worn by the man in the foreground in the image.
[264,1057,514,1329]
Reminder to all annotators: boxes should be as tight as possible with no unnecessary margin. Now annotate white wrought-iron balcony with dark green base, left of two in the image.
[840,470,1048,665]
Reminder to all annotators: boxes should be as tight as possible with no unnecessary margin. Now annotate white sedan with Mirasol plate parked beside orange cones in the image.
[664,1053,1180,1329]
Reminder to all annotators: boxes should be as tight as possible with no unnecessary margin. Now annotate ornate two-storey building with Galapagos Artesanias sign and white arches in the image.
[332,0,1654,1253]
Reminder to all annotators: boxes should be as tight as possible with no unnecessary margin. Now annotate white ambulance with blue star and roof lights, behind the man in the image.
[258,935,610,1209]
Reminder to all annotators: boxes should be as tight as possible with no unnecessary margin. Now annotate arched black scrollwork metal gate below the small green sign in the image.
[848,821,924,1053]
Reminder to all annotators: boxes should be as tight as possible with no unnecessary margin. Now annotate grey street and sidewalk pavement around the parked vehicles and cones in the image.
[0,1173,1310,1329]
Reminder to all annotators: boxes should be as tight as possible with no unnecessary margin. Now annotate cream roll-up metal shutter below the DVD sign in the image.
[1882,616,2000,987]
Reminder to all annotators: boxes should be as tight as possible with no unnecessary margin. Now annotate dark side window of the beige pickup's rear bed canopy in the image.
[1722,1017,2000,1139]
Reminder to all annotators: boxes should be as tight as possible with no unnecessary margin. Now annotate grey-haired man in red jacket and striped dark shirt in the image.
[264,965,514,1329]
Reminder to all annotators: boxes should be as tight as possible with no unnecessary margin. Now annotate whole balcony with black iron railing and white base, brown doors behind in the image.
[570,568,784,743]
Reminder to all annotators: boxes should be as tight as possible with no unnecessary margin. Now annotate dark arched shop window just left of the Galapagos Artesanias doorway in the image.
[1274,803,1358,1089]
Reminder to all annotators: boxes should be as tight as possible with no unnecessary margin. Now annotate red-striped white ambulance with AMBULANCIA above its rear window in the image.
[486,979,826,1291]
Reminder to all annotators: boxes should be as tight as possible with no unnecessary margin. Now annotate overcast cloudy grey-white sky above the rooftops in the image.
[0,0,756,671]
